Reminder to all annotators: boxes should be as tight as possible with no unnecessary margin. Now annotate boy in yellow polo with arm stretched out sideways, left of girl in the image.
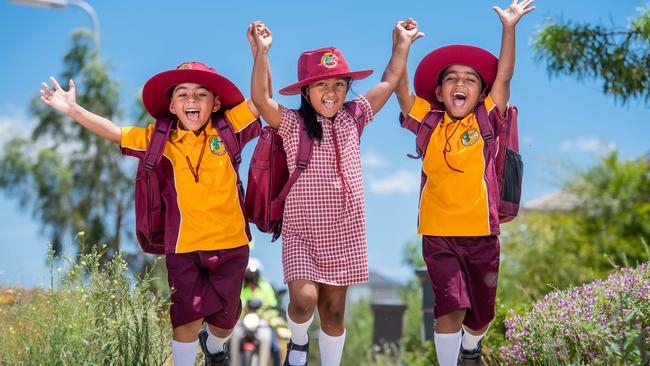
[41,62,261,366]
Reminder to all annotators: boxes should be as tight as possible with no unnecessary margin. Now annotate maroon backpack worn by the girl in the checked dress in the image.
[245,102,365,242]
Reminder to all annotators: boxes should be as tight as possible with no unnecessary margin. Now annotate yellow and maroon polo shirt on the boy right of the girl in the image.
[408,96,499,236]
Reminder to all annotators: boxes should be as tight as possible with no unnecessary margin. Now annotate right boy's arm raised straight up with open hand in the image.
[490,0,535,114]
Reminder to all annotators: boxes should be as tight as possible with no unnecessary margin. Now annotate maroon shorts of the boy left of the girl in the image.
[166,245,249,329]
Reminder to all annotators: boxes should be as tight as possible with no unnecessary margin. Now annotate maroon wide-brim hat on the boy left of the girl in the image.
[142,62,244,118]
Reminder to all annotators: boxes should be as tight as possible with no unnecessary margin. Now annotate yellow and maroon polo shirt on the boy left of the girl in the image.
[120,101,257,253]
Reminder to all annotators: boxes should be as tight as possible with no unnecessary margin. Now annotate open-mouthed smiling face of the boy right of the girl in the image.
[436,65,485,119]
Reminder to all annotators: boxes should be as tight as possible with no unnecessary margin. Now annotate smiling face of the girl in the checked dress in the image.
[307,78,349,118]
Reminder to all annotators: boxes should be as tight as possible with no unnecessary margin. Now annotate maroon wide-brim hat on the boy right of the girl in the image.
[413,45,499,109]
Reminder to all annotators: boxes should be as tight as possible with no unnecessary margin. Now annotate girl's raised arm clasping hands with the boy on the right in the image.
[365,18,424,113]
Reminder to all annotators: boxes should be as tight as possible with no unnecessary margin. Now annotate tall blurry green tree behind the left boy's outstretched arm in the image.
[0,29,133,264]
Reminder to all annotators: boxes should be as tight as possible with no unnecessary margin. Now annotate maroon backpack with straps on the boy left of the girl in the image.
[122,115,261,255]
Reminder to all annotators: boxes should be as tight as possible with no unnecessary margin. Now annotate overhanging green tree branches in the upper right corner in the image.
[533,5,650,103]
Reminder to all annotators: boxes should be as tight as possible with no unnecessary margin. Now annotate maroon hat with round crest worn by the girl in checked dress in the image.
[280,47,372,95]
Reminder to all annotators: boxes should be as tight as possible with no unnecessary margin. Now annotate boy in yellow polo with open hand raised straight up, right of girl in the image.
[395,0,535,366]
